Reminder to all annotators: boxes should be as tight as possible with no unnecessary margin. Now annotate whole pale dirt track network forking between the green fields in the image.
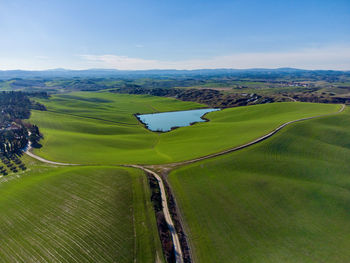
[25,104,345,263]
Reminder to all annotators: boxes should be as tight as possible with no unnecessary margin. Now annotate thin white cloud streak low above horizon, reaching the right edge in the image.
[80,46,350,70]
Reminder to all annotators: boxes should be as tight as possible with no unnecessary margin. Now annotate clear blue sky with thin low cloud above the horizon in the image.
[0,0,350,70]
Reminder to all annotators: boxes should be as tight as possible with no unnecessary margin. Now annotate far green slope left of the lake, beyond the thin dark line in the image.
[42,92,204,124]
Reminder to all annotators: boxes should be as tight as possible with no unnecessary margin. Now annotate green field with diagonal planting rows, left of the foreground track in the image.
[0,158,162,262]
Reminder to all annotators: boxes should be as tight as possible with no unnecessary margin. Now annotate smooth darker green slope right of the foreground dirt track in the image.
[169,109,350,263]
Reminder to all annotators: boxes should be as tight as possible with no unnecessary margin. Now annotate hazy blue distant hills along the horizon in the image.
[0,68,350,80]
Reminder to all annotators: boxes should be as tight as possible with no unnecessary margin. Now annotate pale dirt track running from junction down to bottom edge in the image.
[130,165,183,263]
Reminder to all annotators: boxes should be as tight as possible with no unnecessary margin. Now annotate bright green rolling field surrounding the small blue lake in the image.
[30,92,340,164]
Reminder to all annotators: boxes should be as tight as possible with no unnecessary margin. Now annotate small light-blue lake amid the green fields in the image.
[136,109,220,132]
